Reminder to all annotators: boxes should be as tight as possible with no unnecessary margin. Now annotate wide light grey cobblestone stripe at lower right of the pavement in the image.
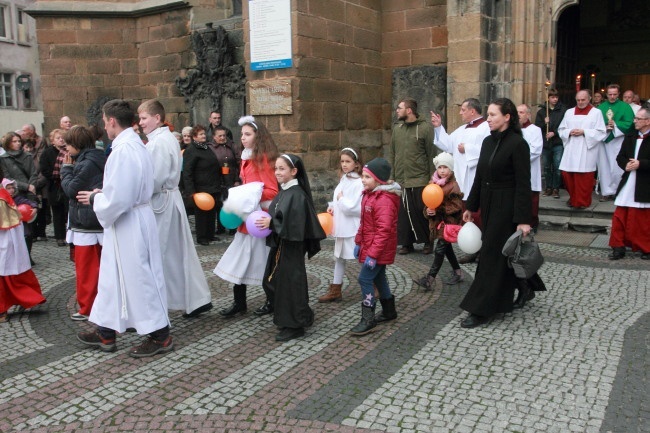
[342,266,650,432]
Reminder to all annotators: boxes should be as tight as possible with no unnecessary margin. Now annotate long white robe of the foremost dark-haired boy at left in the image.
[89,128,169,335]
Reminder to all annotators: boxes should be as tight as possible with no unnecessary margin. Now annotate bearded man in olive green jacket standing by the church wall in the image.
[386,98,439,254]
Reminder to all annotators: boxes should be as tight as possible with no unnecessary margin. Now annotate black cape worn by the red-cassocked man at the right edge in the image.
[616,131,650,203]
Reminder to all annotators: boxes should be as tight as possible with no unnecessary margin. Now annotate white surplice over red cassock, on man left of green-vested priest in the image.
[557,108,607,173]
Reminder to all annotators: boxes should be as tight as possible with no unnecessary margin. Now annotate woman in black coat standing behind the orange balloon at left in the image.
[183,125,222,245]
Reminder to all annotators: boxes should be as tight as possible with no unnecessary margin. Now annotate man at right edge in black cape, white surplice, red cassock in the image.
[609,108,650,260]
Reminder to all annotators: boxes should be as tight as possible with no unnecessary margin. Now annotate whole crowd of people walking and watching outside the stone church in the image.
[0,88,650,344]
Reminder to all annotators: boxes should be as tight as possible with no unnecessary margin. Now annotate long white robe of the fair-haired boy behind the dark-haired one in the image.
[146,126,212,313]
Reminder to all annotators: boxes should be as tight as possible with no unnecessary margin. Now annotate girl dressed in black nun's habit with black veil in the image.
[256,154,325,341]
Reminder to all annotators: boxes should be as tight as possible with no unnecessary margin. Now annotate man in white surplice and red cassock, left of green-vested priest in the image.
[557,90,607,209]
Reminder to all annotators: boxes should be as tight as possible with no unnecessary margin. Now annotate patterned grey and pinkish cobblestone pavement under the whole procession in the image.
[0,228,650,433]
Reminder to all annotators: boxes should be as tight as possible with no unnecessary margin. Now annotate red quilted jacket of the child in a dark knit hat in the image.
[354,183,401,265]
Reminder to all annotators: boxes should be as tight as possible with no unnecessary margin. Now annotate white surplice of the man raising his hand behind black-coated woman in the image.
[434,122,490,195]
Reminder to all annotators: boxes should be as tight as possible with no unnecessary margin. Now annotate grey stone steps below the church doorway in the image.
[539,190,616,233]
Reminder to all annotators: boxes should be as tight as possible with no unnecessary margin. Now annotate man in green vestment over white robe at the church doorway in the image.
[597,84,634,201]
